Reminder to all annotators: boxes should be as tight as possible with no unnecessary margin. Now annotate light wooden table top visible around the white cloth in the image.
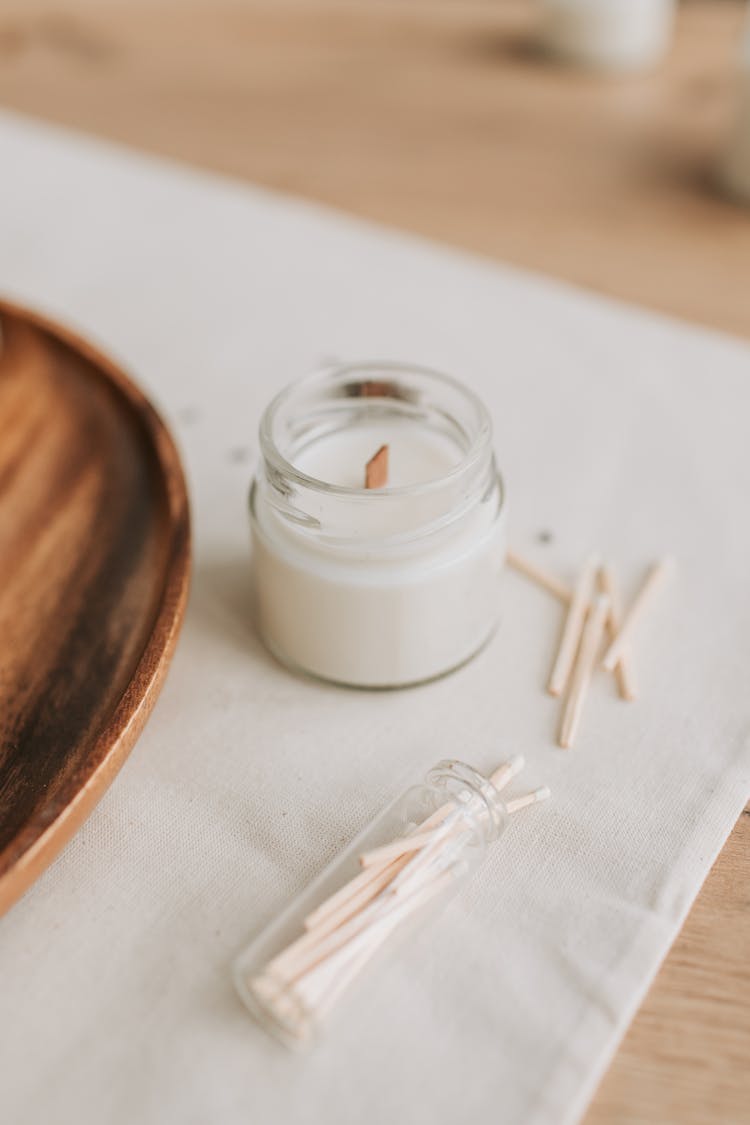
[0,0,750,1125]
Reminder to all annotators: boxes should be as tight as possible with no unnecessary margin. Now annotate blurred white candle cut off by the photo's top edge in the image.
[541,0,675,70]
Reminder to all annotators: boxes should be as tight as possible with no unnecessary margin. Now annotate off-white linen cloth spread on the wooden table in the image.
[0,115,750,1125]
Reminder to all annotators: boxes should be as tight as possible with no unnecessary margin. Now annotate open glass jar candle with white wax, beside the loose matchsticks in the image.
[250,363,506,687]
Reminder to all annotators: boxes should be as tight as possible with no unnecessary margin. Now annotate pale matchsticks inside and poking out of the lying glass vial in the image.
[246,756,550,1043]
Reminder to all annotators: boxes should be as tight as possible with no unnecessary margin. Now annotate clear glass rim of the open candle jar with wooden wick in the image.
[259,360,493,503]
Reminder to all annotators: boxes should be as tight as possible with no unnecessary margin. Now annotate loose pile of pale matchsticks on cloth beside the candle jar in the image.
[507,551,672,749]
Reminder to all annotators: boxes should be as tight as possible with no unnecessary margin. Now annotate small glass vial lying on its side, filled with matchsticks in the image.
[234,758,512,1046]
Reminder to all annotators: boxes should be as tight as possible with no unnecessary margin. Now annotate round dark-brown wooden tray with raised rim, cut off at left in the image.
[0,302,190,911]
